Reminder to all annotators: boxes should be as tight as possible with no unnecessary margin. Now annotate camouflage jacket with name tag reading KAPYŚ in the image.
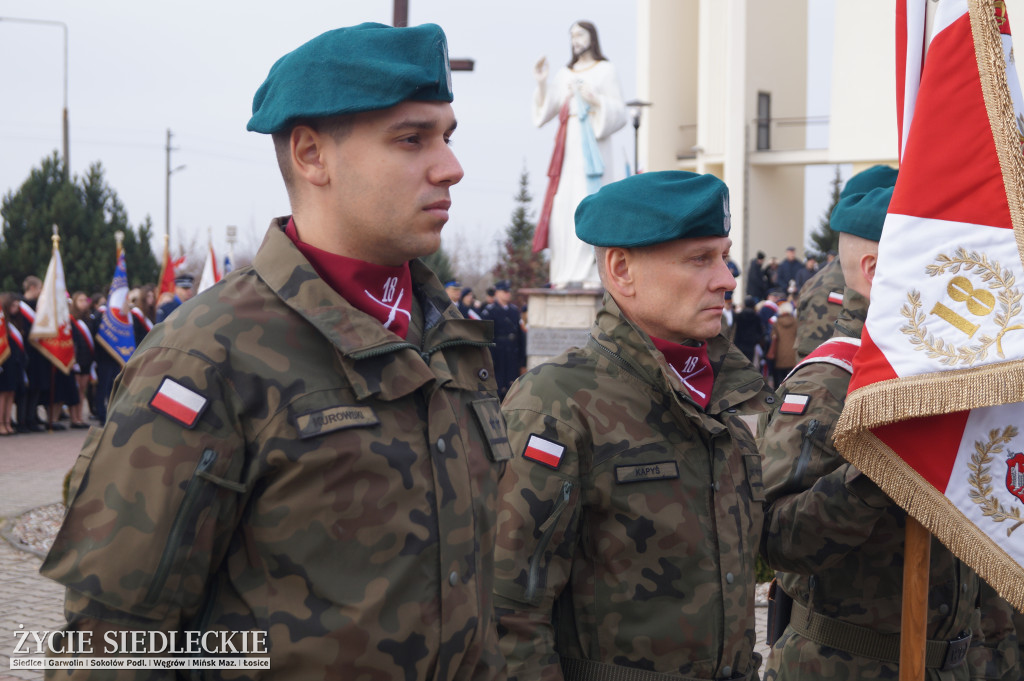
[495,296,774,681]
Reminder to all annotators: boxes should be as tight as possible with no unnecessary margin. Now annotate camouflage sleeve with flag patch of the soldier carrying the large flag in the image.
[758,364,890,574]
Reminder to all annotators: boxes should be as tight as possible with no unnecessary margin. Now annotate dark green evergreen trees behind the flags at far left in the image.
[0,152,160,293]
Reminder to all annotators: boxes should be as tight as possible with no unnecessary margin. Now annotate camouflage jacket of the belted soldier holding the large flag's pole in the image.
[758,289,979,679]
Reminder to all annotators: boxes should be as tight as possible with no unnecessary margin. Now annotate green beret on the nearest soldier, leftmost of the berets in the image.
[246,23,454,133]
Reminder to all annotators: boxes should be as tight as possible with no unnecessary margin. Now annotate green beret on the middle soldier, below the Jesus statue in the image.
[575,170,729,248]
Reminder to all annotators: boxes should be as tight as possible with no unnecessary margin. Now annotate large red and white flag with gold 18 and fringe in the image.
[836,0,1024,610]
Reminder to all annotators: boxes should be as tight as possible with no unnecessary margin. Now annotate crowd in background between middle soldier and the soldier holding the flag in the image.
[725,246,837,386]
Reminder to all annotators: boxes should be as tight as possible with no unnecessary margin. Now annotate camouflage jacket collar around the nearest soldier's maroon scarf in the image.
[253,217,494,399]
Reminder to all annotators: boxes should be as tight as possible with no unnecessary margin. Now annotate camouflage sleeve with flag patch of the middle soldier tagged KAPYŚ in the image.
[495,395,584,681]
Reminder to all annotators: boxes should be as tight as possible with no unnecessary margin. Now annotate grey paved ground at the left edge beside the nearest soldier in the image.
[0,429,88,681]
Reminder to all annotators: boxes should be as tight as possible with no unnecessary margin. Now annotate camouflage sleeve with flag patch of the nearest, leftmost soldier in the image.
[41,346,245,678]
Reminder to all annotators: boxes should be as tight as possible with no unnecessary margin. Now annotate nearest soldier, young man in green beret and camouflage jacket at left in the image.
[43,24,512,681]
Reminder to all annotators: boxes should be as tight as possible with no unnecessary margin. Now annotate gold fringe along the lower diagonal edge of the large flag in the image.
[843,432,1024,612]
